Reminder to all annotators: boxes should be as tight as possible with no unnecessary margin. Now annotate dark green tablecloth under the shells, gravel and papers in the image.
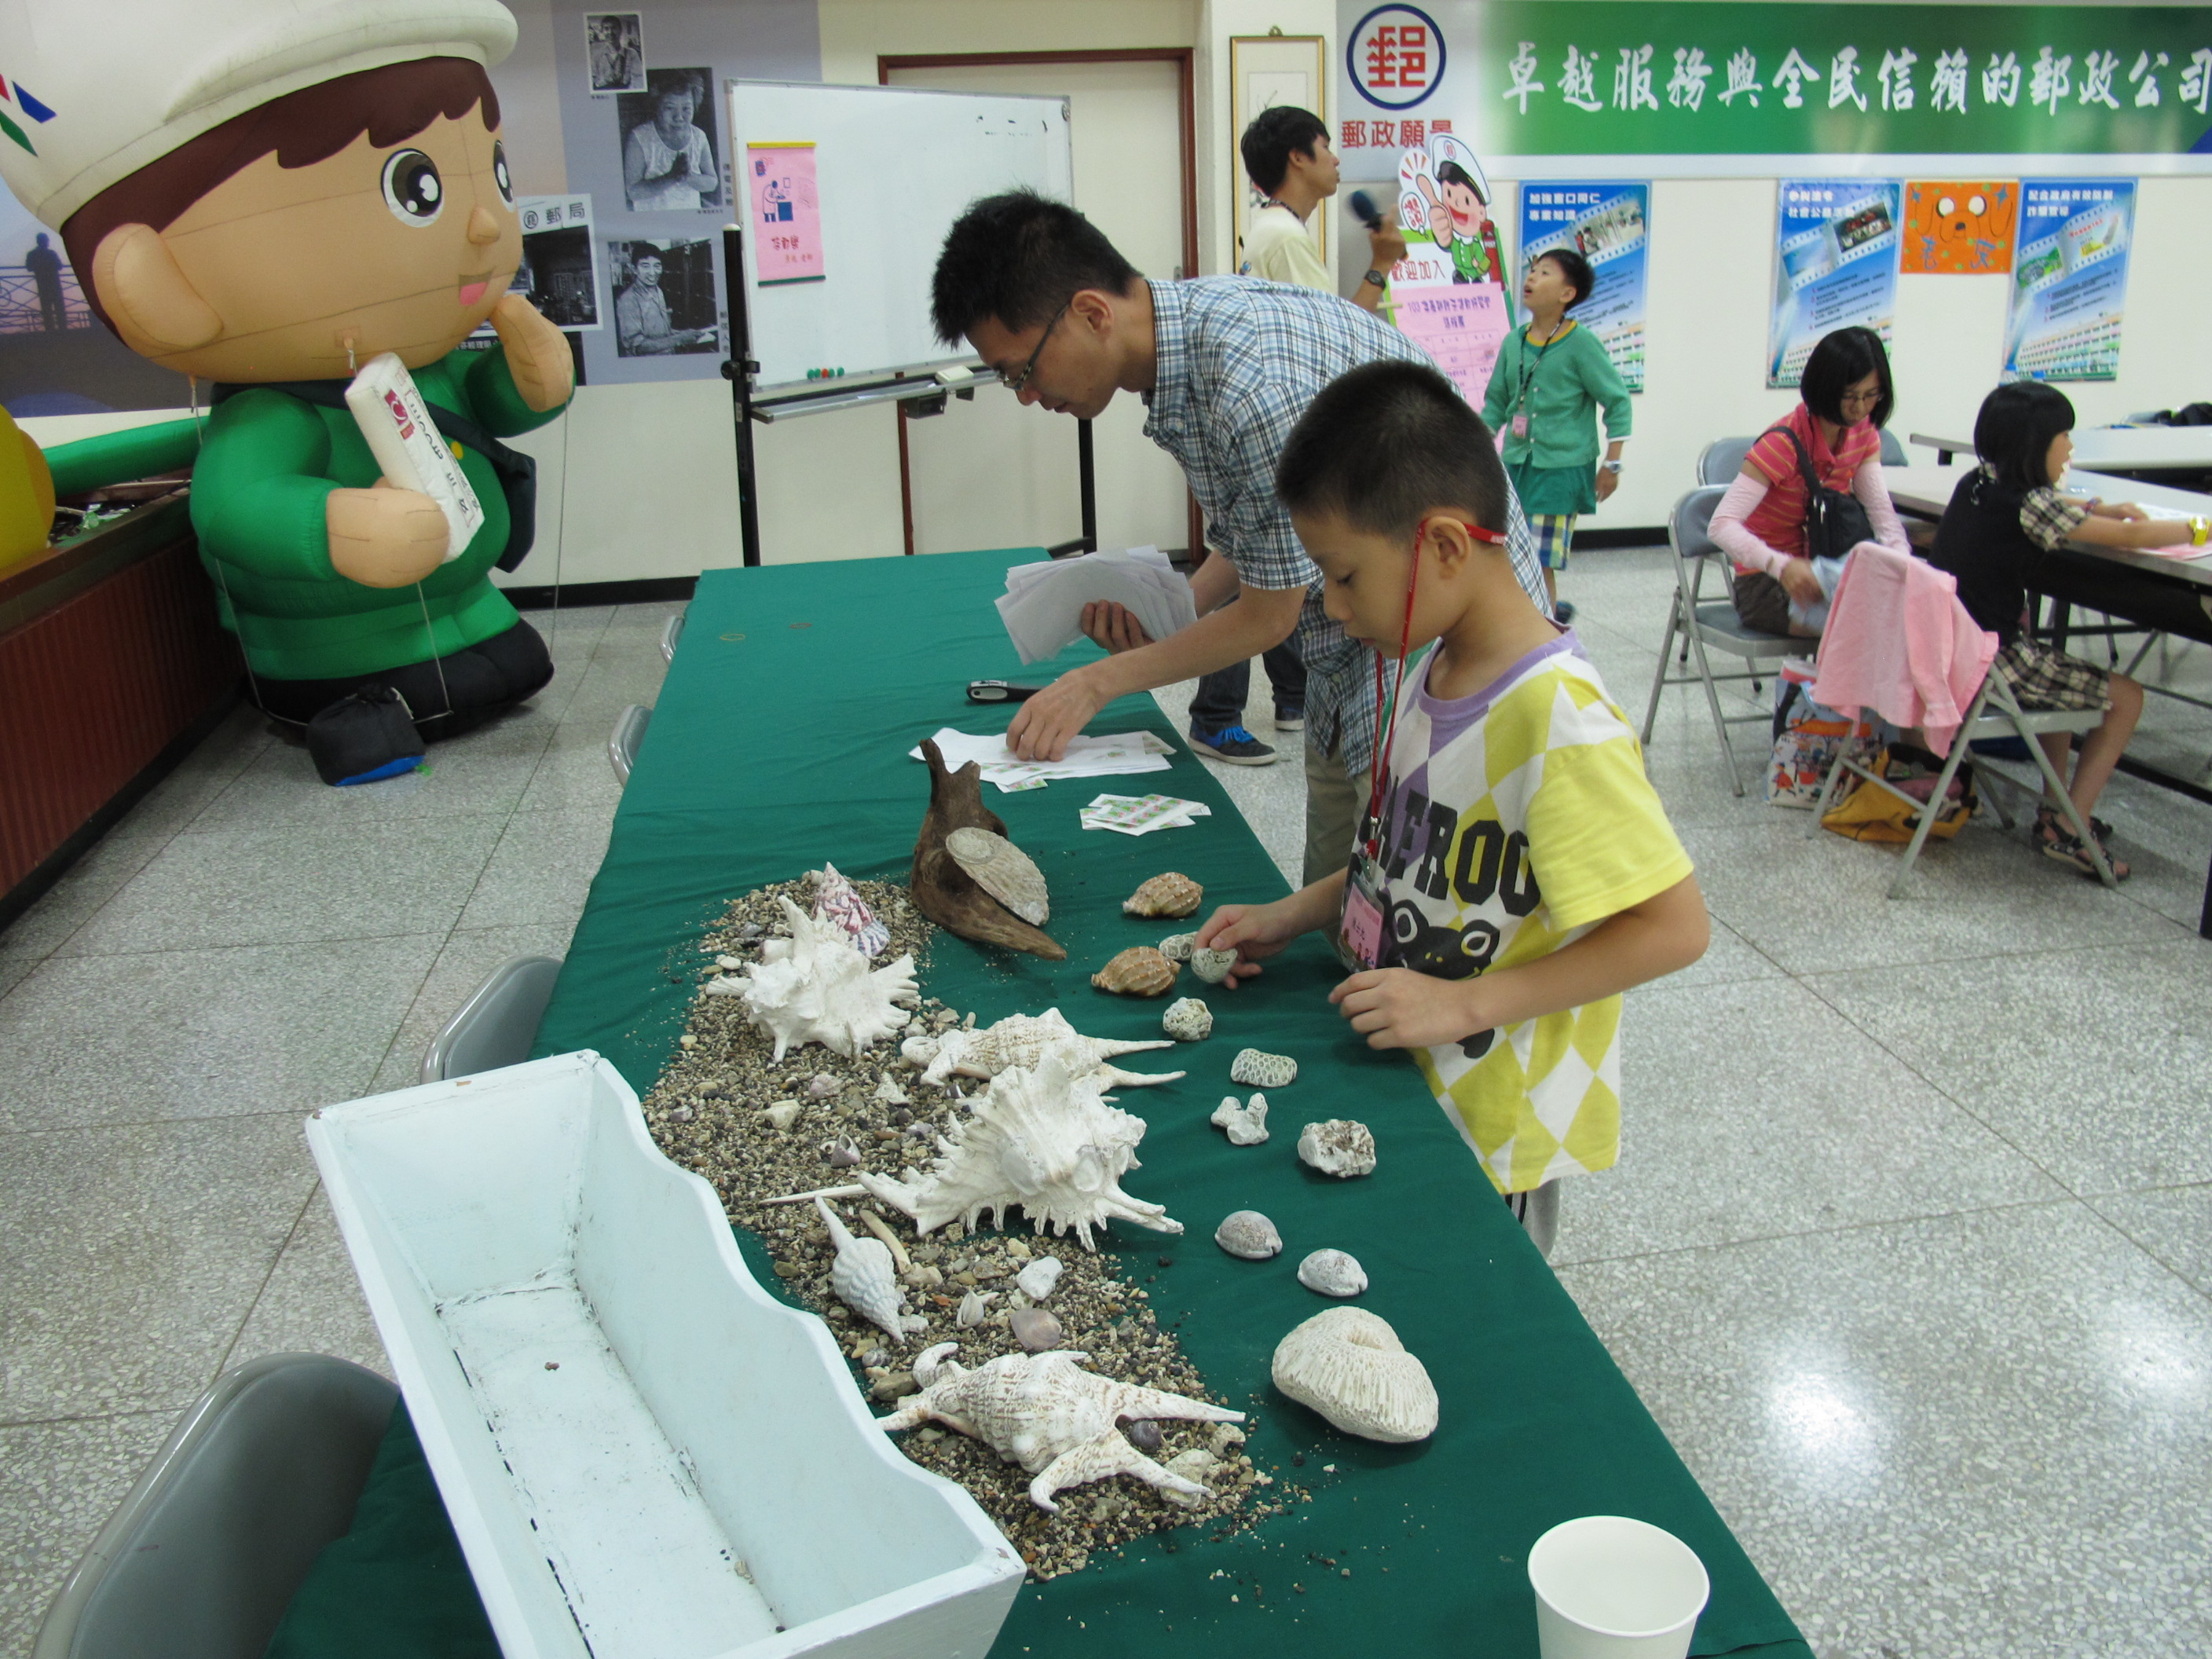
[302,553,1809,1659]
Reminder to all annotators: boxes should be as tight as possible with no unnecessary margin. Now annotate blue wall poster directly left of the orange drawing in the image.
[1767,179,1903,387]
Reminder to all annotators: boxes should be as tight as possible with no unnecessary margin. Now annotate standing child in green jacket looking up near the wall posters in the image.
[1482,247,1630,621]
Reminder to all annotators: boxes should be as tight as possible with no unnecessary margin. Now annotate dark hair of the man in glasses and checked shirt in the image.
[929,190,1137,345]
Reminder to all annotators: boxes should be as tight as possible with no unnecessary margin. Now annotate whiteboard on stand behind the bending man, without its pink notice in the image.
[726,79,1075,394]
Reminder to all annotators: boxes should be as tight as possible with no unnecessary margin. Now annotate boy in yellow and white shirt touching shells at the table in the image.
[1196,363,1708,1252]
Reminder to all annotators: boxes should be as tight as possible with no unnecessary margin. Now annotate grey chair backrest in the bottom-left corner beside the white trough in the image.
[31,1353,398,1659]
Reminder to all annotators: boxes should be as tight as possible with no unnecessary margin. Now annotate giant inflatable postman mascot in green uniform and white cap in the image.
[0,0,575,783]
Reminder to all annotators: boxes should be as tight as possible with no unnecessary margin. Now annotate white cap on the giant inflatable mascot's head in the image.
[0,0,515,230]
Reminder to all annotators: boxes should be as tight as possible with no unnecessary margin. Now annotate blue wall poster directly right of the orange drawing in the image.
[2000,179,2134,380]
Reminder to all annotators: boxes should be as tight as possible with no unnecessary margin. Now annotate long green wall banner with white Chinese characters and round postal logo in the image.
[1336,0,2212,184]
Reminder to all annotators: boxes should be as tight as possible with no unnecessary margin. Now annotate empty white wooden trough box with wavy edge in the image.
[307,1053,1022,1659]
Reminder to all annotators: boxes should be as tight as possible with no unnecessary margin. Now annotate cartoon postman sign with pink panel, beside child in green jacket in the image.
[1389,133,1513,407]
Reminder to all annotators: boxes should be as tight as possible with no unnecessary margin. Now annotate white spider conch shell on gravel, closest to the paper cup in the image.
[876,1342,1243,1515]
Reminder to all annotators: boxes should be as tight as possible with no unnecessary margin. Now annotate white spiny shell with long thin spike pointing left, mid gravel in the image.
[854,1044,1184,1250]
